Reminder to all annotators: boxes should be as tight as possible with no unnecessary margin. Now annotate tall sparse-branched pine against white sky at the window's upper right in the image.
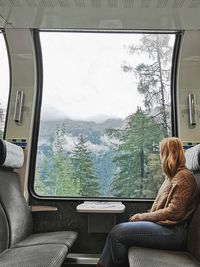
[122,34,172,137]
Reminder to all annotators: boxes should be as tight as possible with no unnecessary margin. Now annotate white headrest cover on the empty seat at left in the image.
[0,139,24,169]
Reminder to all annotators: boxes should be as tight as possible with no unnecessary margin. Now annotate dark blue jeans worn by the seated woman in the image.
[99,221,187,267]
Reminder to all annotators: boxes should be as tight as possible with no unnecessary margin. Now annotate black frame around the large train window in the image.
[28,29,183,202]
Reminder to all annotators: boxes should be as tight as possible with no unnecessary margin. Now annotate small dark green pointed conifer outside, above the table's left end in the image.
[71,136,100,196]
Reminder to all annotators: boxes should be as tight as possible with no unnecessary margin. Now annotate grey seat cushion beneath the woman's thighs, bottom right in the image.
[128,247,200,267]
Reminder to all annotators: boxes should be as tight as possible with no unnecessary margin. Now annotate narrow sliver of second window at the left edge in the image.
[0,32,10,138]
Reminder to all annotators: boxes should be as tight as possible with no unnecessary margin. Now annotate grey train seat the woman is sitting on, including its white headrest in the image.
[128,144,200,267]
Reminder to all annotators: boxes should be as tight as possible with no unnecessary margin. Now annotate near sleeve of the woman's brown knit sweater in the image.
[137,173,197,222]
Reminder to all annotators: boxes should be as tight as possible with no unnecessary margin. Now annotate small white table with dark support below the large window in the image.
[76,201,125,233]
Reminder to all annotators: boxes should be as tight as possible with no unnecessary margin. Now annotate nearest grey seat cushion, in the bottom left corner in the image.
[0,244,68,267]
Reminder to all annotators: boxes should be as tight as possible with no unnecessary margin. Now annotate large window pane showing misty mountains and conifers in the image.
[34,31,175,198]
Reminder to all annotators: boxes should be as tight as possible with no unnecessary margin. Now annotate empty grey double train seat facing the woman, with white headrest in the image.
[0,139,77,267]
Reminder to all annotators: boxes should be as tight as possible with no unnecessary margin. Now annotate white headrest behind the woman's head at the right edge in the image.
[185,144,200,172]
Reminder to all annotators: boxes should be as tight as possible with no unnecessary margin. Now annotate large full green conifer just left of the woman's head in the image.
[110,108,164,197]
